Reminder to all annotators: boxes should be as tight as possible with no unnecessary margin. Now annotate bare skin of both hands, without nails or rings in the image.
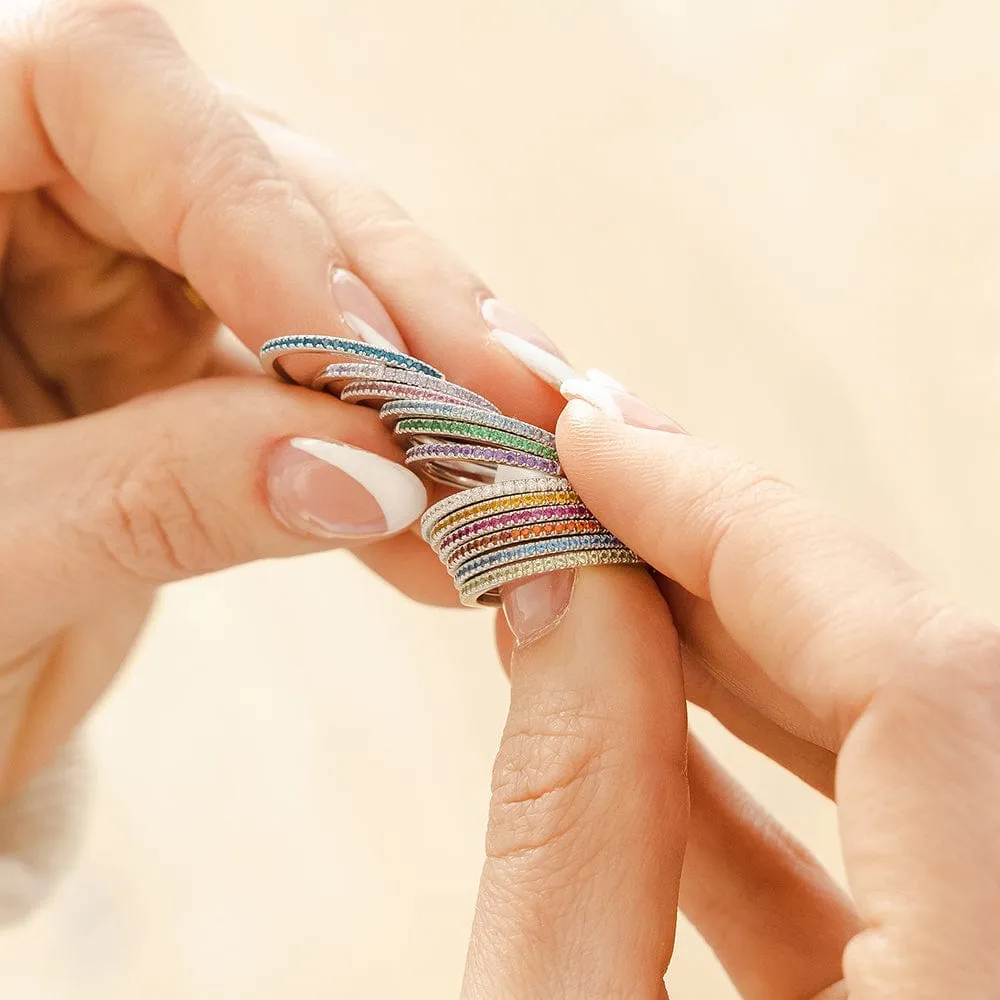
[0,2,1000,1000]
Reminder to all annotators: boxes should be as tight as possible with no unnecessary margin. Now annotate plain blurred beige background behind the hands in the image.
[0,0,1000,1000]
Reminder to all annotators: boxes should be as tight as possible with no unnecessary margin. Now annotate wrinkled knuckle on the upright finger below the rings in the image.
[487,708,618,871]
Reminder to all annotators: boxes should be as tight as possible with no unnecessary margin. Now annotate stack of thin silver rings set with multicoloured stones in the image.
[260,336,639,606]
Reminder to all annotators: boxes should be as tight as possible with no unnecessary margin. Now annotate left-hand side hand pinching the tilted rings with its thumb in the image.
[0,2,557,909]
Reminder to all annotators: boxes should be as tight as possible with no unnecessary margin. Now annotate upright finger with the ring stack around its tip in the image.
[463,568,687,1000]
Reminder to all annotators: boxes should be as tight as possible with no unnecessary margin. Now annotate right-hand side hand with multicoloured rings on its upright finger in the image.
[464,389,1000,1000]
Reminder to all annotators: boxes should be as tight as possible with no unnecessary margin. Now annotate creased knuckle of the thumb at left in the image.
[92,438,233,584]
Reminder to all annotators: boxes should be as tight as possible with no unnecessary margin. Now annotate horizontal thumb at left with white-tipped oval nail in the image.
[0,378,426,664]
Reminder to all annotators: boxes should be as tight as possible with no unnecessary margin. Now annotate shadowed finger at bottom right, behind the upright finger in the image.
[680,738,860,1000]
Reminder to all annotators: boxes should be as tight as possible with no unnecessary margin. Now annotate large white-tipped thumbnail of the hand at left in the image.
[267,438,427,540]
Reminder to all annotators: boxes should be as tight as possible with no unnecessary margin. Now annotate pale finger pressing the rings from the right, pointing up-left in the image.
[558,401,954,748]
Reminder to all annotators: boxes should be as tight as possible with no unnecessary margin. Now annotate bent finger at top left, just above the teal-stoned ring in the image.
[0,0,368,349]
